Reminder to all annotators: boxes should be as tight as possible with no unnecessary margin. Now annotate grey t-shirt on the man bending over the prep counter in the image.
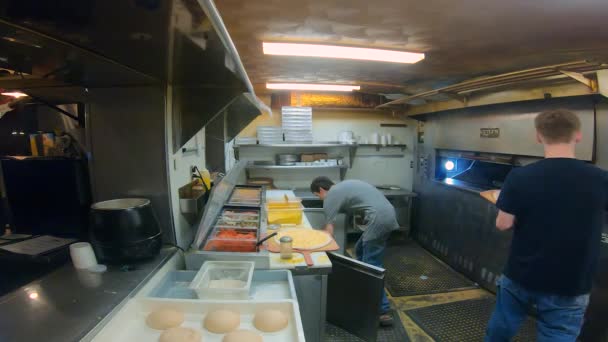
[323,179,399,241]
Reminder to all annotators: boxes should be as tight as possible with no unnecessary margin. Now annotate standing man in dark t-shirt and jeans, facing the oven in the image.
[486,110,608,342]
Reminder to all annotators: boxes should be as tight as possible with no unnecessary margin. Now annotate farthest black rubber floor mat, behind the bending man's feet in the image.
[384,242,477,297]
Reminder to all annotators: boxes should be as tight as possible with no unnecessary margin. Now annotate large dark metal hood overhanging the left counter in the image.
[0,0,264,151]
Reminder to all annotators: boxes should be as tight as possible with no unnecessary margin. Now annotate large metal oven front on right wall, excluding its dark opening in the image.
[413,98,608,290]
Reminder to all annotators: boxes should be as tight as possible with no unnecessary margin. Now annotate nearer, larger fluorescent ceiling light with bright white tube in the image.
[262,42,424,63]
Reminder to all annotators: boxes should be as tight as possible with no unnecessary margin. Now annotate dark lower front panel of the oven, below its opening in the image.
[413,182,512,290]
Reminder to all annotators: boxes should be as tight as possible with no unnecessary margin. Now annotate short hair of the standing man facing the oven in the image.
[534,109,581,144]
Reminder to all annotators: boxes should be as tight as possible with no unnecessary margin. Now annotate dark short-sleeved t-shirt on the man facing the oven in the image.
[496,158,608,296]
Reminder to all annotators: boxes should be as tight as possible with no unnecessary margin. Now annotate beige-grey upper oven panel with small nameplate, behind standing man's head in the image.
[434,97,595,160]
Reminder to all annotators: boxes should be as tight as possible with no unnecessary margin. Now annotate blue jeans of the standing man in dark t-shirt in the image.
[485,276,589,342]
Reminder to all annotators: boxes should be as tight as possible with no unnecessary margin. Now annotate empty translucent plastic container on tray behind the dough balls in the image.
[189,261,255,299]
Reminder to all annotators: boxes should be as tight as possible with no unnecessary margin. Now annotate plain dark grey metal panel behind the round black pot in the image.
[87,86,175,243]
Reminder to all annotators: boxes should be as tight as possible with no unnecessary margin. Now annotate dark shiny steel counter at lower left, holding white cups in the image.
[0,248,176,342]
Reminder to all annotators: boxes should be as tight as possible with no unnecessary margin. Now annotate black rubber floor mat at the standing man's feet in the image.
[405,298,536,342]
